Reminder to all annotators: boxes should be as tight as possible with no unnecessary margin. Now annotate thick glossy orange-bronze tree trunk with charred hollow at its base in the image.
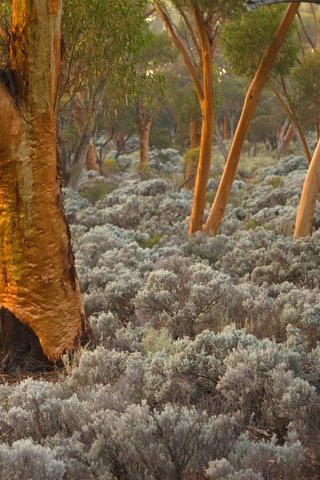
[0,0,86,370]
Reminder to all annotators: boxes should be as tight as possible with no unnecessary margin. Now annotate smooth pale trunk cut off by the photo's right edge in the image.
[294,140,320,238]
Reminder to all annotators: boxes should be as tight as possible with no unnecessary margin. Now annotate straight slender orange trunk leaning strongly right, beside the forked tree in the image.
[204,4,299,235]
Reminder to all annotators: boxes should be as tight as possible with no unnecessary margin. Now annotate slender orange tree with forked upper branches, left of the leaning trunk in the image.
[154,0,242,234]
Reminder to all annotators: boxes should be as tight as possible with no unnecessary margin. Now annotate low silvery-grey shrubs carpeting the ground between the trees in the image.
[0,152,320,480]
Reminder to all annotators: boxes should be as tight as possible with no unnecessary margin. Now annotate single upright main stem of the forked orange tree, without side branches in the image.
[189,8,214,235]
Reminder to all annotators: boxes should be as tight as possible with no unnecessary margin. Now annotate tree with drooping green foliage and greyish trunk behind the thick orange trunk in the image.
[60,0,147,189]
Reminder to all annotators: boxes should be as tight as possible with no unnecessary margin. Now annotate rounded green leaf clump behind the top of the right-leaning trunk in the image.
[221,5,298,77]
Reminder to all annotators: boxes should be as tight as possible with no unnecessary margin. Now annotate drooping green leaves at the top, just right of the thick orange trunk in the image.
[62,0,147,96]
